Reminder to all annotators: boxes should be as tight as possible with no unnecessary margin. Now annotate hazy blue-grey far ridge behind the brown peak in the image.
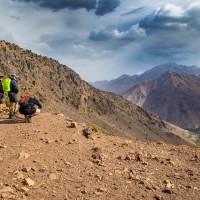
[91,63,200,95]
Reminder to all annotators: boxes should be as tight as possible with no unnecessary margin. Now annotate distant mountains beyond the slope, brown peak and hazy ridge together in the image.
[93,63,200,130]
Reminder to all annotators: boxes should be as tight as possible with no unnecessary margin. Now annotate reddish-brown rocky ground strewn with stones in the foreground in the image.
[0,113,200,200]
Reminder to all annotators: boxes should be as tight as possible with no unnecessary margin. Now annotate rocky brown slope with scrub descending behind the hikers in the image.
[0,41,194,144]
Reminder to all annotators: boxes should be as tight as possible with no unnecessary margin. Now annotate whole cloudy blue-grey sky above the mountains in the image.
[0,0,200,82]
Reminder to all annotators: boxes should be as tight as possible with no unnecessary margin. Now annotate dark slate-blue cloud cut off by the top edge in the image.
[13,0,120,15]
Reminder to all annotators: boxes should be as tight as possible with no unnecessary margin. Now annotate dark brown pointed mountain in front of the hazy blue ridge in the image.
[124,71,200,128]
